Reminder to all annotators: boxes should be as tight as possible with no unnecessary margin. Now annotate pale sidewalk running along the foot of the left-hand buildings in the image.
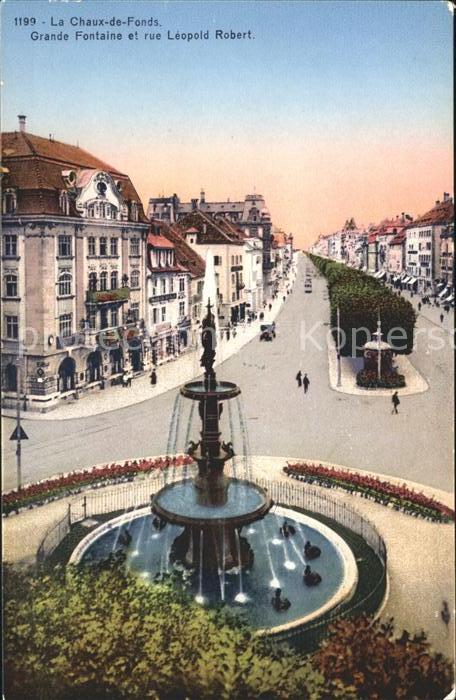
[2,260,297,421]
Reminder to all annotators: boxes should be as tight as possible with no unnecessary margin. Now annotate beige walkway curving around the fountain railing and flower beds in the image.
[3,457,455,658]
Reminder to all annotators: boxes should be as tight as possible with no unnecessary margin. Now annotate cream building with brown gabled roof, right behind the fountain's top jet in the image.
[172,210,246,325]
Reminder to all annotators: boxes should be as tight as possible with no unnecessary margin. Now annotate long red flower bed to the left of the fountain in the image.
[2,455,193,515]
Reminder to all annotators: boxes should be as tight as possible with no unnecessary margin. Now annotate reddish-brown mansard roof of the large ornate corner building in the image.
[2,131,147,222]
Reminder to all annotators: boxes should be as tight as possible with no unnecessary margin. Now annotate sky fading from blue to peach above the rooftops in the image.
[1,0,453,247]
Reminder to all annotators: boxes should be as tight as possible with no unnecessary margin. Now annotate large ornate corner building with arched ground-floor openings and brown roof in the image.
[1,116,150,410]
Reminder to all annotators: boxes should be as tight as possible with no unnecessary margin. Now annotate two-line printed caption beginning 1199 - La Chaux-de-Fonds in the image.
[13,16,255,43]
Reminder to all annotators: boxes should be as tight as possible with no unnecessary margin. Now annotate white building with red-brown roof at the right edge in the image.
[405,192,454,292]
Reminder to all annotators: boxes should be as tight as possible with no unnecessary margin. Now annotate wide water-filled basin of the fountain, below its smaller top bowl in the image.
[152,477,272,528]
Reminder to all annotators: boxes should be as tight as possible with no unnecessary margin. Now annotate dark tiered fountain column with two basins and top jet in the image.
[151,299,272,574]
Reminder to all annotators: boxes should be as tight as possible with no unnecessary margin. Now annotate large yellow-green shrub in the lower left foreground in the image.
[4,562,328,700]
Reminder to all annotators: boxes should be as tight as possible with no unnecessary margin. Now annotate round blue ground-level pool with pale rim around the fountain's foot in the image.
[70,507,358,631]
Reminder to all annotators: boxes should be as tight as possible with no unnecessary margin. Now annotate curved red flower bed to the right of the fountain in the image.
[283,462,454,522]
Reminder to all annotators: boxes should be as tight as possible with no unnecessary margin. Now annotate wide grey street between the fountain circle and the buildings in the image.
[4,260,453,490]
